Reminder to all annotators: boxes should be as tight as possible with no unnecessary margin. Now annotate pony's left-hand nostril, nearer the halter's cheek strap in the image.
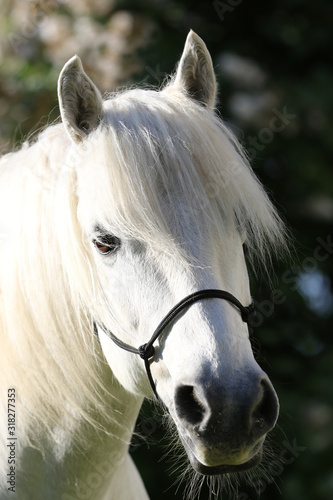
[175,385,205,425]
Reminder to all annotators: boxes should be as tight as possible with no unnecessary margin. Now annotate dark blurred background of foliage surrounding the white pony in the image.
[0,0,333,500]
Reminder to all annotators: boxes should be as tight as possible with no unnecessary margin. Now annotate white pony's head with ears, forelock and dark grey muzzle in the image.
[59,32,283,475]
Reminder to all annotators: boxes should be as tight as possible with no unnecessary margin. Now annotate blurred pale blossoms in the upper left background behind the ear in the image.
[0,0,152,150]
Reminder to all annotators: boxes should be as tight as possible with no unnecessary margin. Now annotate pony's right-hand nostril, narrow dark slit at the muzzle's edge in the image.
[252,379,279,433]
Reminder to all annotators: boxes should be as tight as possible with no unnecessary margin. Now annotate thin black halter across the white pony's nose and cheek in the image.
[94,290,254,399]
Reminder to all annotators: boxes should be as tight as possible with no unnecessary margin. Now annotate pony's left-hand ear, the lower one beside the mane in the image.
[58,56,103,144]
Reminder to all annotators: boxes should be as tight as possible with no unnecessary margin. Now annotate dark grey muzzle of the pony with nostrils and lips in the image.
[174,372,279,475]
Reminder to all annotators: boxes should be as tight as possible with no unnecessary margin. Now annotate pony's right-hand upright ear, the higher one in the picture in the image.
[171,30,216,108]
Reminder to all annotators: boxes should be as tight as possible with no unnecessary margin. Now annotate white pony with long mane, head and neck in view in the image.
[0,32,284,500]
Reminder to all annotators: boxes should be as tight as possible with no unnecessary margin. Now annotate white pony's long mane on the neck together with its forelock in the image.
[0,78,283,484]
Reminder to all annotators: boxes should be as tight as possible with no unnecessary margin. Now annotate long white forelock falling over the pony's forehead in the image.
[85,88,285,272]
